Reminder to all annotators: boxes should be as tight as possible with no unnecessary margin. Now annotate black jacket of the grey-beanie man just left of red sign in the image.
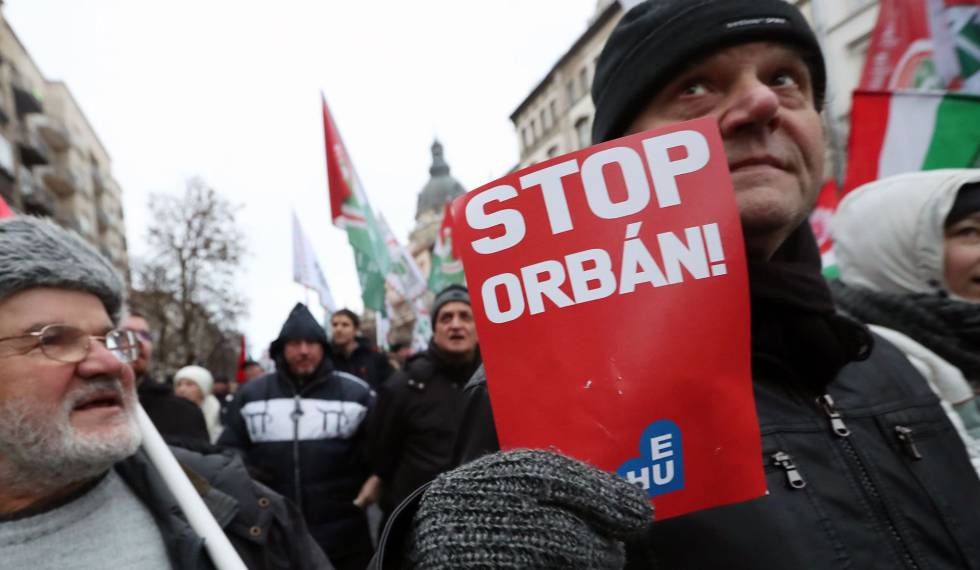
[368,346,481,513]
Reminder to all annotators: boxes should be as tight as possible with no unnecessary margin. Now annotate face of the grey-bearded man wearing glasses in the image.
[0,288,140,487]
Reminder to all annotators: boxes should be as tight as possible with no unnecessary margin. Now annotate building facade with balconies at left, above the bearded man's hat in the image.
[0,6,129,275]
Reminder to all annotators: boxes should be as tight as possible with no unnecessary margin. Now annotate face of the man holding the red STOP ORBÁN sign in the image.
[628,42,824,259]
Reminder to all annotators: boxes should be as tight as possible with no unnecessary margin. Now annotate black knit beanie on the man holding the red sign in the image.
[592,0,827,144]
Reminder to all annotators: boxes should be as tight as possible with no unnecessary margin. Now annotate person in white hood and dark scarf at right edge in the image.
[831,169,980,468]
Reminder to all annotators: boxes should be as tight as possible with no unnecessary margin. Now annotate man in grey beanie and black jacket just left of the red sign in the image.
[368,285,481,514]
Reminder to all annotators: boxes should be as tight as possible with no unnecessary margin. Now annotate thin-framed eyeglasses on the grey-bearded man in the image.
[0,325,139,364]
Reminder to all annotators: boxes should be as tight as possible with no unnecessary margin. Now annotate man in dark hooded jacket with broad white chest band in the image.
[218,303,374,570]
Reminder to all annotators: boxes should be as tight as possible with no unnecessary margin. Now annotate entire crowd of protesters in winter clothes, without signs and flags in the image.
[0,0,980,570]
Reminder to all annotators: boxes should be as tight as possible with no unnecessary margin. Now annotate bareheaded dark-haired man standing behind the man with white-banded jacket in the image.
[330,309,393,390]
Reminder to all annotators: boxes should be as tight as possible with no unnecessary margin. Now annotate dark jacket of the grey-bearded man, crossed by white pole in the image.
[115,448,333,570]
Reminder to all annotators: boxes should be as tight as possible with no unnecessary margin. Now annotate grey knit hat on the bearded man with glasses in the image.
[0,216,123,322]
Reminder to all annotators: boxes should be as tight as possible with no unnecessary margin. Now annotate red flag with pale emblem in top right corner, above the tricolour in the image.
[860,0,980,91]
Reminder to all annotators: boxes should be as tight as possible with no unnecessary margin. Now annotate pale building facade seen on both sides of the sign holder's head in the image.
[510,0,878,180]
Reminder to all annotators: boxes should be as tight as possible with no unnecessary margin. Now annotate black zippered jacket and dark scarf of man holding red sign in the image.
[372,226,980,570]
